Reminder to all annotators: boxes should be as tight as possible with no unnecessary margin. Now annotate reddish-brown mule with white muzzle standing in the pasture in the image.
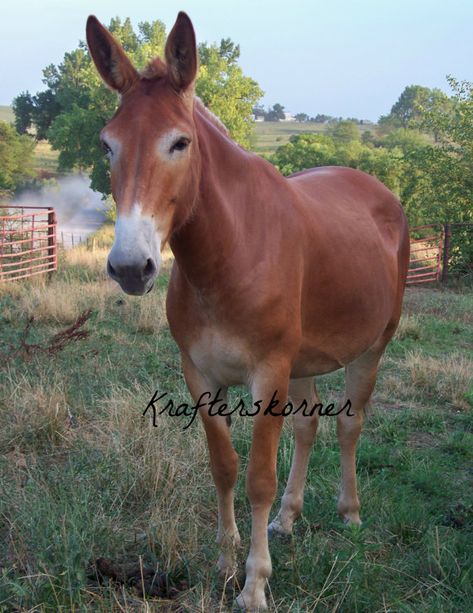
[87,12,409,610]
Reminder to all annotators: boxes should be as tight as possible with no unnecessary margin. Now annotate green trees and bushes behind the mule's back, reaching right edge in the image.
[270,77,473,234]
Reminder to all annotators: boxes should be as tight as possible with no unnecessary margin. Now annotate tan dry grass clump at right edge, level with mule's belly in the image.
[405,352,473,410]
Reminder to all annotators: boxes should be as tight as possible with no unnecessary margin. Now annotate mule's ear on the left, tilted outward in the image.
[86,15,139,94]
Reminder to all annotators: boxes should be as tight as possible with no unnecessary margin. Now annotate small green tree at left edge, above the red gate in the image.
[0,121,34,197]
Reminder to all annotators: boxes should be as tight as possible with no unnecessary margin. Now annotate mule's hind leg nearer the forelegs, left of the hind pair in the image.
[269,377,319,534]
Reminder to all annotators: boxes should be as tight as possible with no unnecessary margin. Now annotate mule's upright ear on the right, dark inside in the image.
[165,11,197,92]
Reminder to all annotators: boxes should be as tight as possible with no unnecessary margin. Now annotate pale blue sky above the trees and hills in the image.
[0,0,473,121]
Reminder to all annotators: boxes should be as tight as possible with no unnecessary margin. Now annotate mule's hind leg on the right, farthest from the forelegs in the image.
[337,341,387,525]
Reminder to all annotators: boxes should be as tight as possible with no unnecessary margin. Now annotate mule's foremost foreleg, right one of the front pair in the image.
[237,360,289,611]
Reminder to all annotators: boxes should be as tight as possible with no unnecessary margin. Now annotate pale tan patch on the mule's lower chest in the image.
[187,327,251,386]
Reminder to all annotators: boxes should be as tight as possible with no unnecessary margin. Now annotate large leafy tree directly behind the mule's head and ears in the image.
[14,17,263,194]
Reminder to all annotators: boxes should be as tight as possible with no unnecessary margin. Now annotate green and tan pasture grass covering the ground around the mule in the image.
[0,230,473,613]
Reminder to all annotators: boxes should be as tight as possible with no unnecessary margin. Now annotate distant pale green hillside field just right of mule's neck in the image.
[251,121,375,153]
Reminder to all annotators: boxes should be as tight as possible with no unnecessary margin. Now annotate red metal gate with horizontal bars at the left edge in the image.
[0,205,57,282]
